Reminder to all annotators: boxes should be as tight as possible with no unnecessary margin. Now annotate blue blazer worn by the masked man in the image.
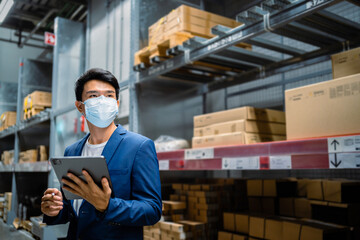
[44,125,162,240]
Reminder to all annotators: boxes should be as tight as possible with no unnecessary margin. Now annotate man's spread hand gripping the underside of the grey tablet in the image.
[62,170,111,212]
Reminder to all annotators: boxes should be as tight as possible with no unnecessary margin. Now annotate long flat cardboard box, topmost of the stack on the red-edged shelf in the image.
[194,107,285,128]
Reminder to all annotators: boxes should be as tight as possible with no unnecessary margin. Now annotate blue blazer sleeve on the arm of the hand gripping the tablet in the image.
[97,139,162,226]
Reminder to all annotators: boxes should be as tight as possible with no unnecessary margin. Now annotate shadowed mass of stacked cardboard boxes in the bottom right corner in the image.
[218,179,360,240]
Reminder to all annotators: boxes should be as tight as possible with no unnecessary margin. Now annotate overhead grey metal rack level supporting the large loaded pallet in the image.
[135,0,360,90]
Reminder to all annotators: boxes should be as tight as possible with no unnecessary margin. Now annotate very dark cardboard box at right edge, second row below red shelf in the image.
[310,201,360,227]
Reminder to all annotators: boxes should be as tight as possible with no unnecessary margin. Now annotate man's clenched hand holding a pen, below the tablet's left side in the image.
[41,188,63,217]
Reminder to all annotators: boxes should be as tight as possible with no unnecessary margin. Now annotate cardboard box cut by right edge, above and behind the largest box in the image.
[331,47,360,78]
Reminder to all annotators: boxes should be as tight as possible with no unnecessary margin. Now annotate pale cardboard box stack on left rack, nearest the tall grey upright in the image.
[23,91,51,119]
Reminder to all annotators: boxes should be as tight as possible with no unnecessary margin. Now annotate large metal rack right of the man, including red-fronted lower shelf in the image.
[130,0,360,176]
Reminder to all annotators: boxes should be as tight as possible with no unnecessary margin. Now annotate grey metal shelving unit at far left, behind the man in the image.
[0,18,85,239]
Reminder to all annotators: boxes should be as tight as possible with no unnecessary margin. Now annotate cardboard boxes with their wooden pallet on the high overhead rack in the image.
[134,5,251,66]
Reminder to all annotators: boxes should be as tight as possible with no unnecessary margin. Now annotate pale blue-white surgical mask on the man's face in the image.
[84,95,119,128]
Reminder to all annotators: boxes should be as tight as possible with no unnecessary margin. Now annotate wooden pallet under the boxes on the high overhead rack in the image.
[134,32,251,71]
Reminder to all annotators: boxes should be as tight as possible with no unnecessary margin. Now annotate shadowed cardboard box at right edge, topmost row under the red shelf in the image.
[323,180,360,203]
